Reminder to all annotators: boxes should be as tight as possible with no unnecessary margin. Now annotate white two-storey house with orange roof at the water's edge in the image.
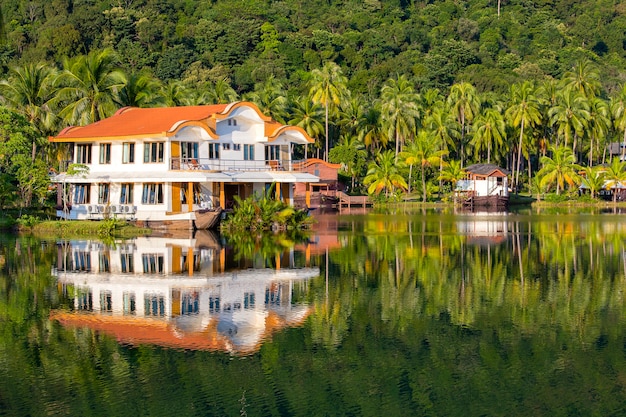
[50,102,319,228]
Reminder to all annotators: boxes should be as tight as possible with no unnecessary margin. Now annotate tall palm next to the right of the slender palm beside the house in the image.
[380,75,420,156]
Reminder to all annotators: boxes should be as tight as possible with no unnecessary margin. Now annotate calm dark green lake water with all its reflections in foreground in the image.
[0,210,626,416]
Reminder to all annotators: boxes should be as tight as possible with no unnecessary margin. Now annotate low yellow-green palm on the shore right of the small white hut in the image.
[537,146,582,195]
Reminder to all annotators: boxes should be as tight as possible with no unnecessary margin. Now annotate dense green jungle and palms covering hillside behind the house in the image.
[0,0,626,204]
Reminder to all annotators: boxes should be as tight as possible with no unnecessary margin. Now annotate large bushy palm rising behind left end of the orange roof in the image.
[55,49,125,125]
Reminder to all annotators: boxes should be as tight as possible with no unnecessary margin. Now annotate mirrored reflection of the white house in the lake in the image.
[51,232,320,354]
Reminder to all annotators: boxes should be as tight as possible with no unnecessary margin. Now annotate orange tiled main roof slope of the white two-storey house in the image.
[50,104,229,142]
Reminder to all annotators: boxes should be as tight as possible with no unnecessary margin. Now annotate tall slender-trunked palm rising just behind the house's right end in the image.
[310,61,349,161]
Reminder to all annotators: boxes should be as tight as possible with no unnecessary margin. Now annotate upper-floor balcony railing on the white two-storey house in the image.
[170,158,305,171]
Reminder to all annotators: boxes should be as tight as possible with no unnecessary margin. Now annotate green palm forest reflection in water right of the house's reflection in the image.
[312,213,626,346]
